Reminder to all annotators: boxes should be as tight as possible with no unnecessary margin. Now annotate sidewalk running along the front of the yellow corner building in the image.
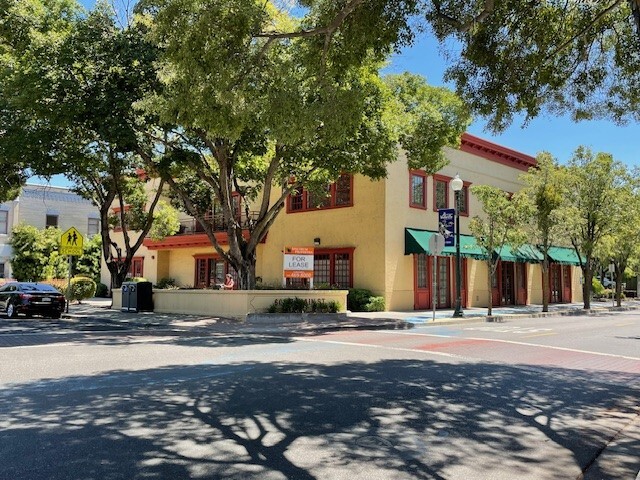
[63,298,640,332]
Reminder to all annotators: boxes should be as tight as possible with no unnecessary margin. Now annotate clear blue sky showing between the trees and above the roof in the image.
[41,4,640,186]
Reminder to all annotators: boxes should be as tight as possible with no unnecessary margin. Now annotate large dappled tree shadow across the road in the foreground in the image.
[0,359,640,480]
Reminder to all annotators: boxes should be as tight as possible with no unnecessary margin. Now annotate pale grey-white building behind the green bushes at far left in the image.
[0,184,100,278]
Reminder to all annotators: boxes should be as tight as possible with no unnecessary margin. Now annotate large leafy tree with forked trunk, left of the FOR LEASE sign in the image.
[139,0,470,288]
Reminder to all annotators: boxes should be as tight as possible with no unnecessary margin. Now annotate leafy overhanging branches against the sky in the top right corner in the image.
[236,0,640,130]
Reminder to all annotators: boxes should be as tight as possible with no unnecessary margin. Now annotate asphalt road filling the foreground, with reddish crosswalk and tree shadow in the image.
[0,312,640,480]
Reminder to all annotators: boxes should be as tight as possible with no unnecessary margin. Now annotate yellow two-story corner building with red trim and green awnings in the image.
[102,134,582,310]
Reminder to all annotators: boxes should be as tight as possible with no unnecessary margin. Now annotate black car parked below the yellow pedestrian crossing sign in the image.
[0,282,65,318]
